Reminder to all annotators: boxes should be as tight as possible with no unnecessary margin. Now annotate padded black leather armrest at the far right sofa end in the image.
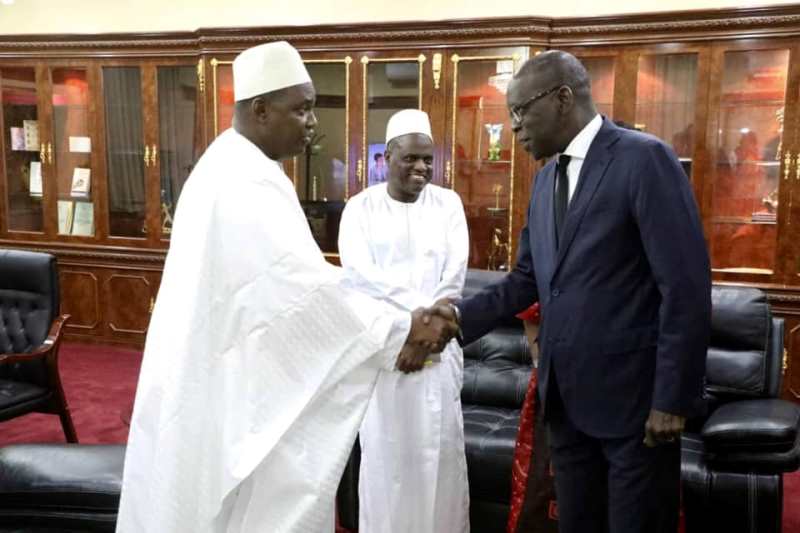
[701,399,800,472]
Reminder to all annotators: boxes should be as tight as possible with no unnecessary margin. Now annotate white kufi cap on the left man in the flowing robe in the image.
[233,41,311,102]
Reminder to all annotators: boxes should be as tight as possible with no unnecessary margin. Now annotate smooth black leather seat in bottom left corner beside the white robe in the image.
[0,444,125,515]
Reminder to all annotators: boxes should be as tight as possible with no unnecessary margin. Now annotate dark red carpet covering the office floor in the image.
[0,343,800,533]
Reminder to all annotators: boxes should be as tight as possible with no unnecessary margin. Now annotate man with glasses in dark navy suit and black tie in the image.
[455,50,711,533]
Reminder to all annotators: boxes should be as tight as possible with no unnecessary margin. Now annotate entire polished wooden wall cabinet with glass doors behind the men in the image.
[0,6,800,399]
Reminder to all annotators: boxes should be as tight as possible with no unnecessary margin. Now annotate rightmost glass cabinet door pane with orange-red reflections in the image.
[711,50,789,273]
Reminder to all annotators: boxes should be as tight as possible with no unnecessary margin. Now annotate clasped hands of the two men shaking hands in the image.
[397,299,459,374]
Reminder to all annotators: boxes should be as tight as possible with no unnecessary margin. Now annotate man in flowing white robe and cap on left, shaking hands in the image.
[117,42,455,533]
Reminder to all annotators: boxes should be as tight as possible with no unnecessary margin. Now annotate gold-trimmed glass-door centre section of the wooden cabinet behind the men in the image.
[209,46,530,270]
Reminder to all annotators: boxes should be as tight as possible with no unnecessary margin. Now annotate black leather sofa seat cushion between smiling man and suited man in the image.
[463,405,520,504]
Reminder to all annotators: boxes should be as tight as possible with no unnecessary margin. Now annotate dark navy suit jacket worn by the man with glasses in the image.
[457,118,711,438]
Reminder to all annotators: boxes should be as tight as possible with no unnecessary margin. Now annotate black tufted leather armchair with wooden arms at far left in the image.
[0,250,78,442]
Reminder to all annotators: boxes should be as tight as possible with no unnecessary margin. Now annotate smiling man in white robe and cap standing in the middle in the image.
[339,109,469,533]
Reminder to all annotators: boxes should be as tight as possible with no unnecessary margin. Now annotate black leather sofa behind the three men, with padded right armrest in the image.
[339,270,800,533]
